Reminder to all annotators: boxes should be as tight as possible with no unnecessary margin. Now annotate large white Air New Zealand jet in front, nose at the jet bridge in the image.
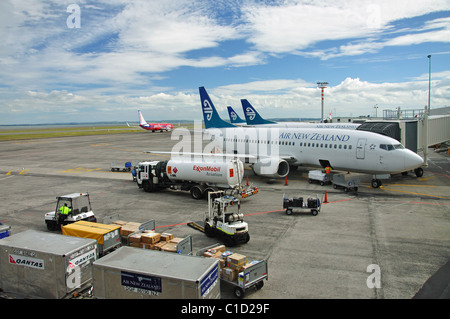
[199,87,423,188]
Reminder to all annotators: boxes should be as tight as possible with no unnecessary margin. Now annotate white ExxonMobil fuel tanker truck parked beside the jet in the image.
[136,159,258,199]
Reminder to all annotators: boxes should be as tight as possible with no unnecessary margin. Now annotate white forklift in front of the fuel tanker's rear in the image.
[204,191,250,246]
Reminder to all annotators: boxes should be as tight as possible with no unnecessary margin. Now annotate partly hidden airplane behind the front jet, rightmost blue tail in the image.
[241,99,361,130]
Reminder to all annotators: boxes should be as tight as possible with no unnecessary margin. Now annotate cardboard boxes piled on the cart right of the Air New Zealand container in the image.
[203,245,251,281]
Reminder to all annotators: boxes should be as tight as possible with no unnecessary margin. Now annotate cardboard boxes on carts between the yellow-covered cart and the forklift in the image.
[113,220,183,253]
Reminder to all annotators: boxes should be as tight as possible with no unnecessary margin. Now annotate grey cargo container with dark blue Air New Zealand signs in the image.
[93,247,220,299]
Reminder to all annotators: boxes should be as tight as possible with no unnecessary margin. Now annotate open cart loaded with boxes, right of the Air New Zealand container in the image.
[196,244,268,298]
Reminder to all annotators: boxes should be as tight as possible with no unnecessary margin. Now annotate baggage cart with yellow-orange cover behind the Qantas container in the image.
[62,220,121,256]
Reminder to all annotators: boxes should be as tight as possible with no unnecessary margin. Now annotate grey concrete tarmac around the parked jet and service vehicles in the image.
[0,131,450,299]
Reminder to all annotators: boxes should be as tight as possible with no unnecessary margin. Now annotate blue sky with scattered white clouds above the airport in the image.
[0,0,450,125]
